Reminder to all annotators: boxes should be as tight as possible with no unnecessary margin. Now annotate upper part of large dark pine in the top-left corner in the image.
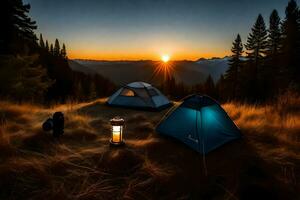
[0,0,37,54]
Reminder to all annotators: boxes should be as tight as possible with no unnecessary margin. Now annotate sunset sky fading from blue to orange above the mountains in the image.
[25,0,288,60]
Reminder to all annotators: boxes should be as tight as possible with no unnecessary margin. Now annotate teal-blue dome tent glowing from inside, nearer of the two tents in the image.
[156,95,241,154]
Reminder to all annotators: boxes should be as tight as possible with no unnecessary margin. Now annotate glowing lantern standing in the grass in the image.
[110,117,125,146]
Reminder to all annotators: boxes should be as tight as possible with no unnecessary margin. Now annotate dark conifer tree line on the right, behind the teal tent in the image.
[160,0,300,102]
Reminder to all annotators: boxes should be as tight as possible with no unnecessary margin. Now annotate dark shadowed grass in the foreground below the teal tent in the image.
[131,137,296,199]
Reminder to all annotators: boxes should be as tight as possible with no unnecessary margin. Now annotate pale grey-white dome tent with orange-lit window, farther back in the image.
[107,82,172,110]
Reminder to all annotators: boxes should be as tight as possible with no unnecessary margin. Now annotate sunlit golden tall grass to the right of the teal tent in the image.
[223,96,300,153]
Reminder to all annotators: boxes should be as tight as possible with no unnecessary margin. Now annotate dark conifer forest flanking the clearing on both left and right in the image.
[0,0,300,104]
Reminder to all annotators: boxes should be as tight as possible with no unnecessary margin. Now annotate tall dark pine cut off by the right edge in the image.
[282,0,300,87]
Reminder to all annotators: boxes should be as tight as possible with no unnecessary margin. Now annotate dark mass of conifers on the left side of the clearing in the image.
[0,0,115,103]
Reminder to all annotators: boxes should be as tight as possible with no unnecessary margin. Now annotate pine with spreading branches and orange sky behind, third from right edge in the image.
[245,14,268,67]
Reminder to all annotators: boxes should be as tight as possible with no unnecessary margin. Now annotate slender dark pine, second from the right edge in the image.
[267,10,281,57]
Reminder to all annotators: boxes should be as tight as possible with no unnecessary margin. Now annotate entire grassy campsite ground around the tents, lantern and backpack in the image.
[0,99,300,199]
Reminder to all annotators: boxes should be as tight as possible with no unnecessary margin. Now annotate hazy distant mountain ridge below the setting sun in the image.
[69,56,230,85]
